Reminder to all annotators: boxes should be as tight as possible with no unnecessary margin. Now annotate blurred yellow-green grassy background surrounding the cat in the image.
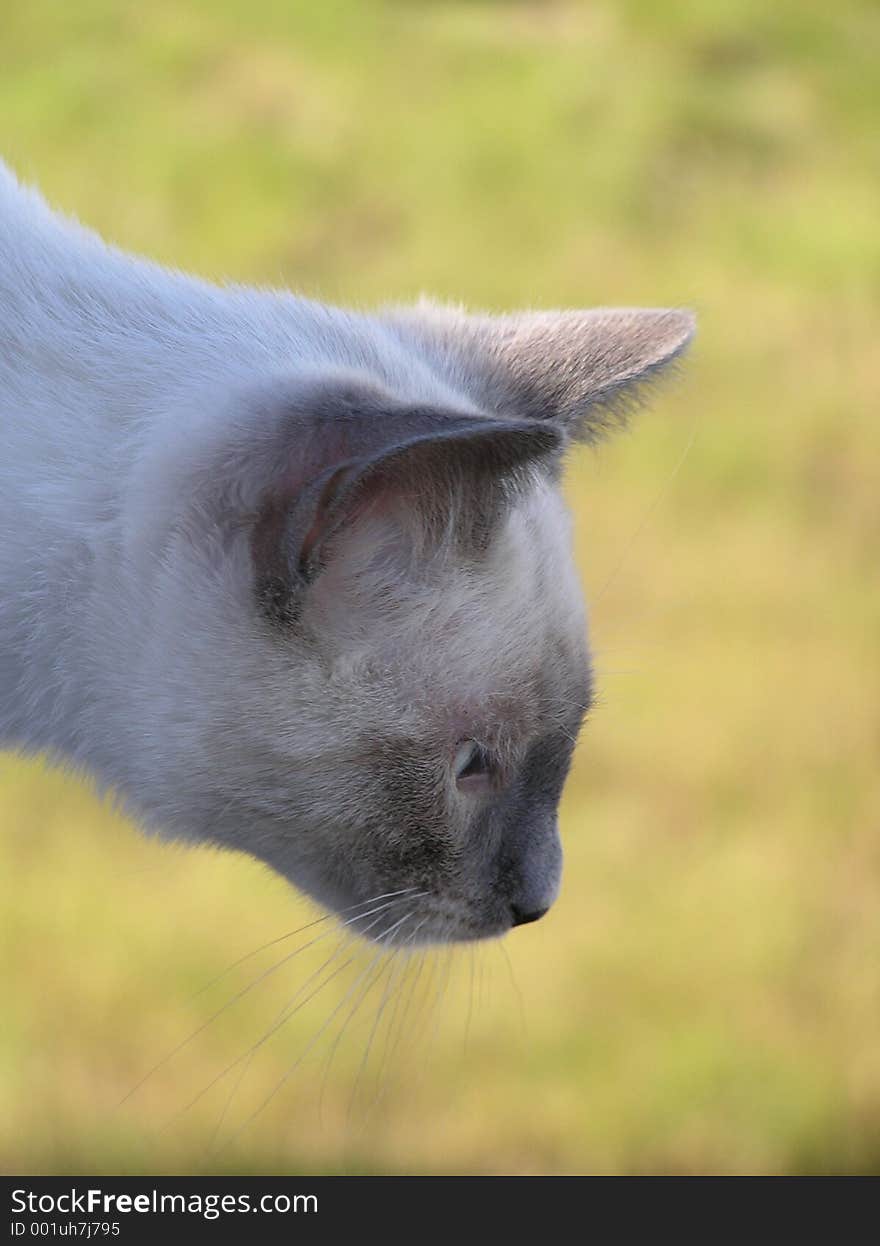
[0,0,880,1172]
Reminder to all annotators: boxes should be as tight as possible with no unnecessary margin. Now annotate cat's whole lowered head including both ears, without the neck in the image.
[121,305,693,943]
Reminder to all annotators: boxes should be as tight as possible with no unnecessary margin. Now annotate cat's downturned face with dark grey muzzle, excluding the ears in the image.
[246,480,590,941]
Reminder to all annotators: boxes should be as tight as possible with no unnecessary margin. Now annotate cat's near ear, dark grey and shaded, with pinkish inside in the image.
[251,390,563,622]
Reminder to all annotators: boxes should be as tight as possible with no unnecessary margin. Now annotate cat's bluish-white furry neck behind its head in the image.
[0,163,284,769]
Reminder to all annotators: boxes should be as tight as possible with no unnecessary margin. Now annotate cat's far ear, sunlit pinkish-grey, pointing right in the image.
[388,302,696,441]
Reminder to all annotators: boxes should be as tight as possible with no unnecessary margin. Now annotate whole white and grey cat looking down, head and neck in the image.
[0,163,694,944]
